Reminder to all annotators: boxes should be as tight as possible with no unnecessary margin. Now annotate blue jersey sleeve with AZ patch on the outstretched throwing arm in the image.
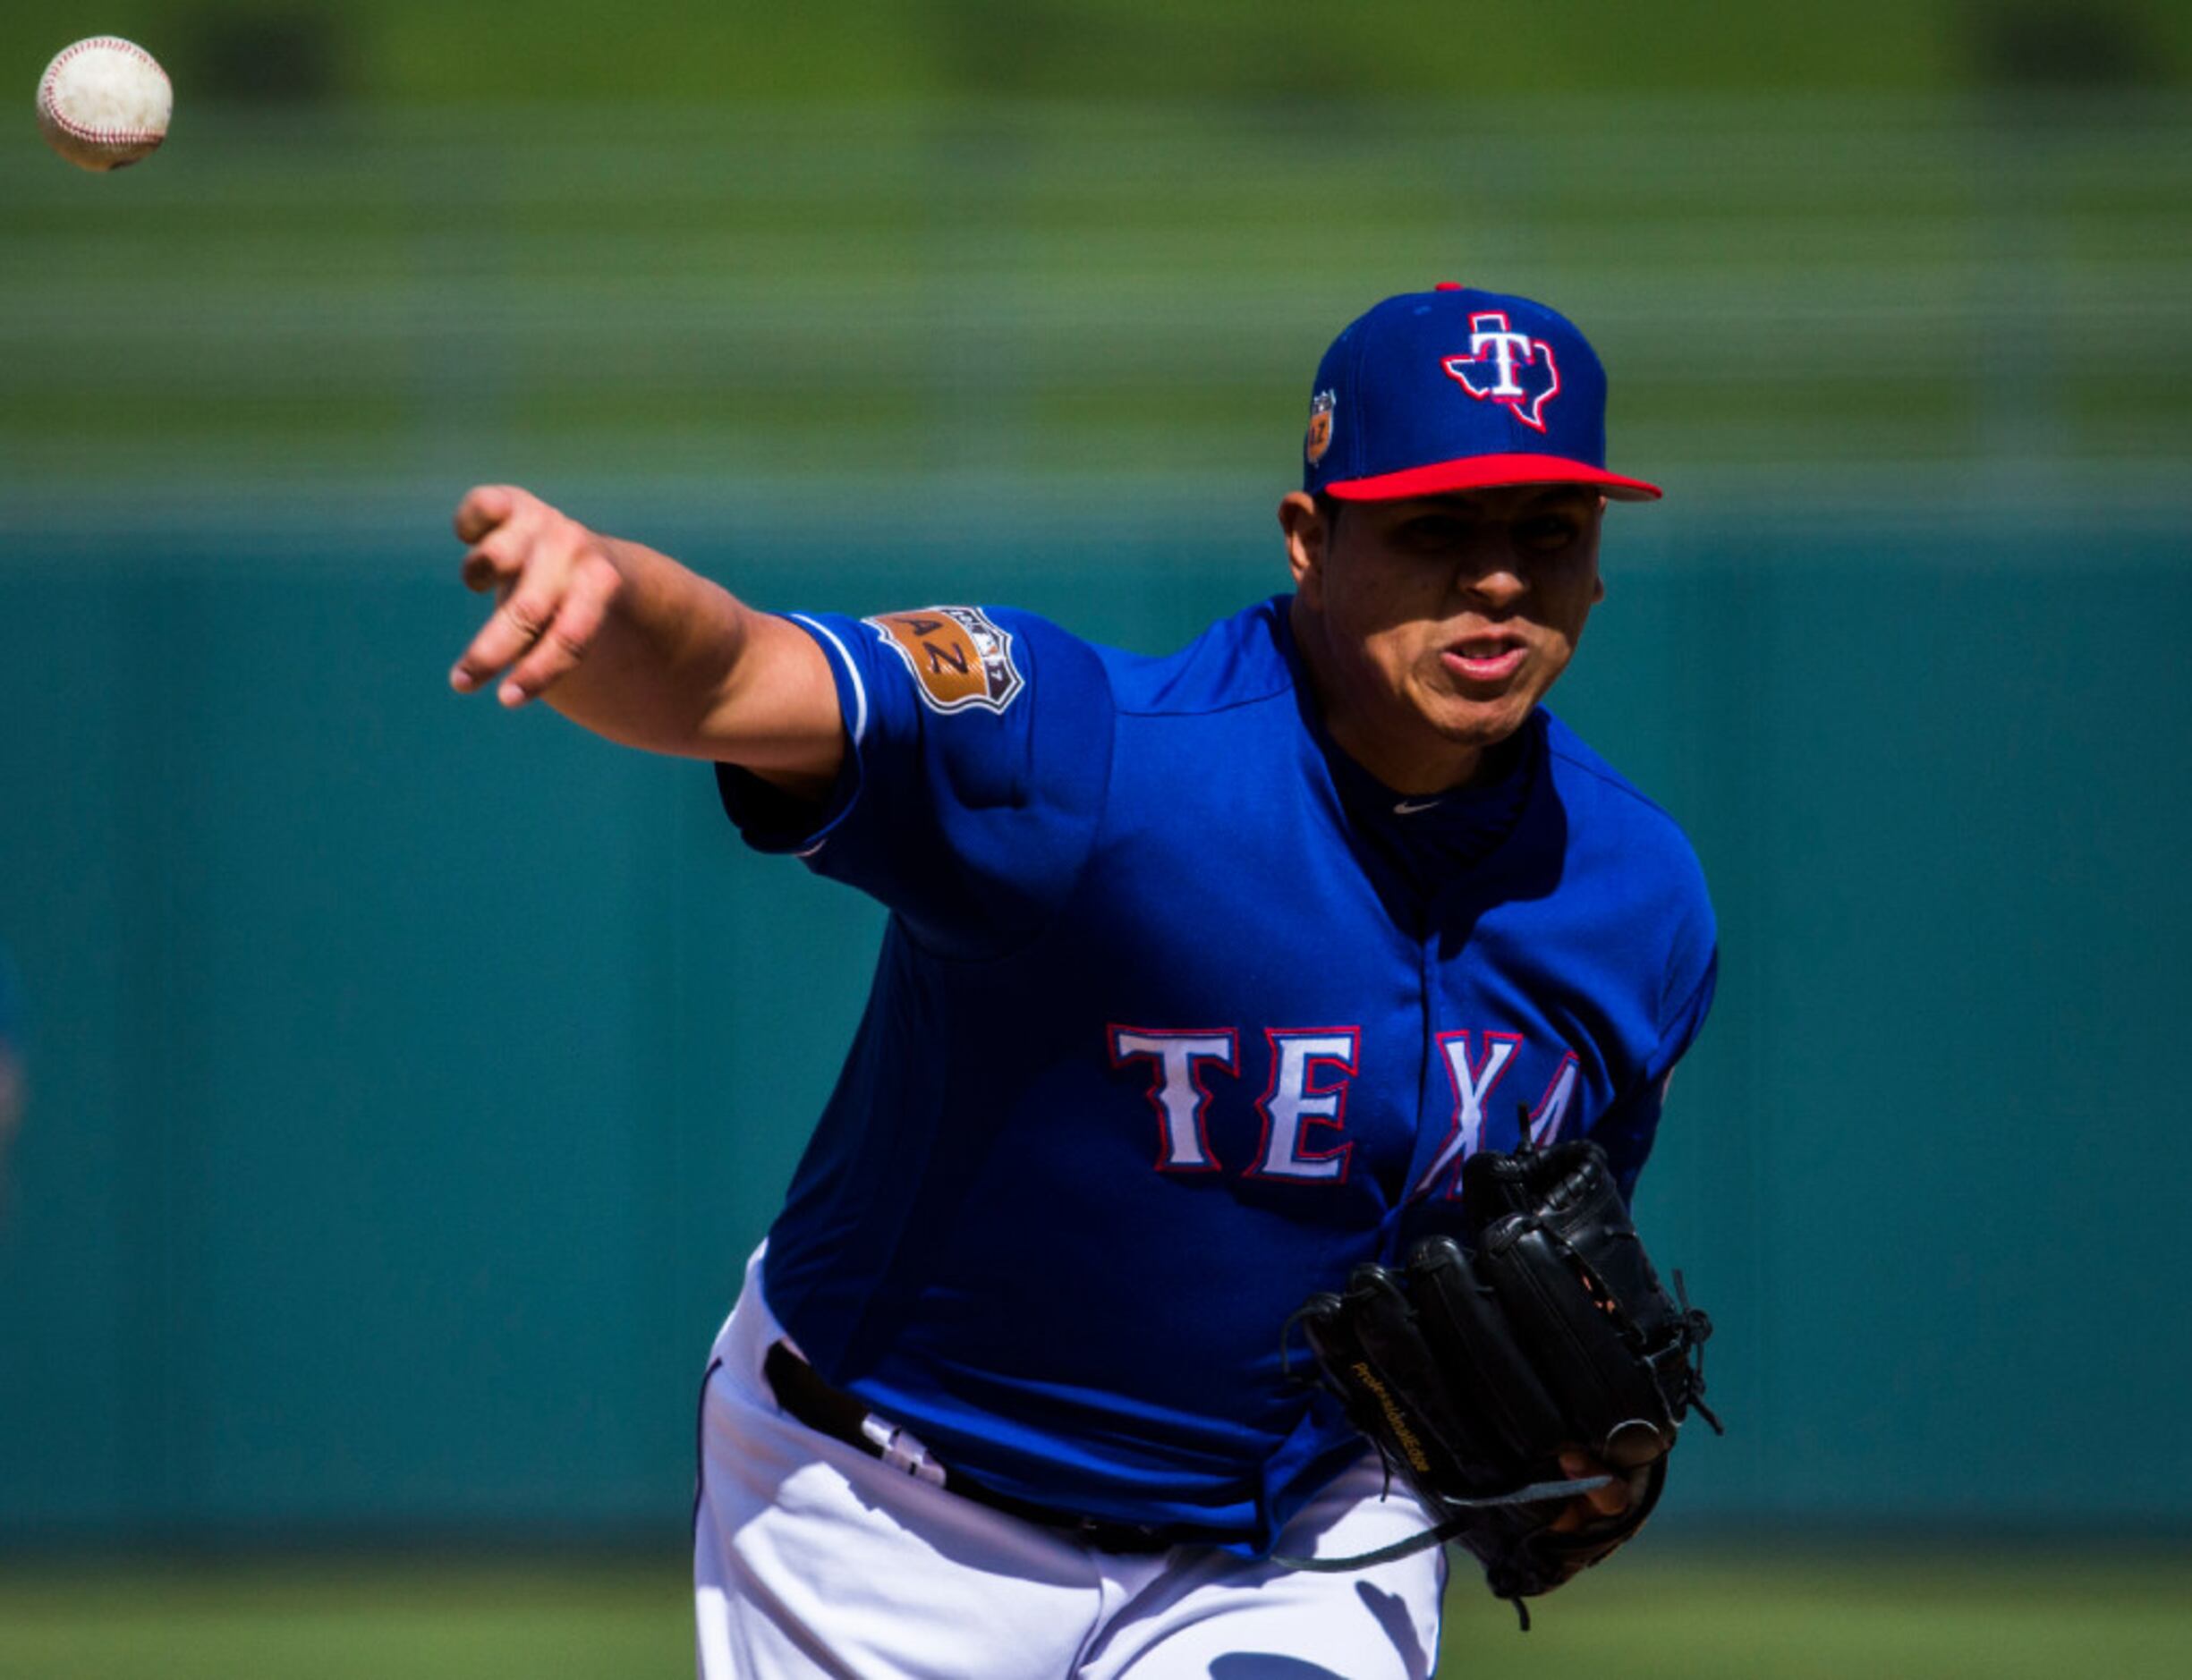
[717,607,1114,957]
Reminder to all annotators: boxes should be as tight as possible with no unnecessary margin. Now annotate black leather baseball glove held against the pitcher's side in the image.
[1278,1128,1720,1627]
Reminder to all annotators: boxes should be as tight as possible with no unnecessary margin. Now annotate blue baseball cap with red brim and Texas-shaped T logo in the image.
[1302,283,1660,502]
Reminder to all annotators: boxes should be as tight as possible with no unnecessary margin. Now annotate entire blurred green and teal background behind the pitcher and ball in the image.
[0,0,2192,1678]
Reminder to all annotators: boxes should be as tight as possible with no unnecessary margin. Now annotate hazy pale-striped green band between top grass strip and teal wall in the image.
[0,96,2192,506]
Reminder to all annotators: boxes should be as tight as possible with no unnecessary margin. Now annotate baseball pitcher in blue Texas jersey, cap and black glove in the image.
[452,284,1714,1680]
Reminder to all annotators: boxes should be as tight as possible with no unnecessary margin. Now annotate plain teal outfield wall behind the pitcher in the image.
[0,497,2192,1544]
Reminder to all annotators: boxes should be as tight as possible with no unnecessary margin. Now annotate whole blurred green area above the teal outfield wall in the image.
[0,0,2192,502]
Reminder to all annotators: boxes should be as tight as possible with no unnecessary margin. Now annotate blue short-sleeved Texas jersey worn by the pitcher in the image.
[719,598,1714,1553]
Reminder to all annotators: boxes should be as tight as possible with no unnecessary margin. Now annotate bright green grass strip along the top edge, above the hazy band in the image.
[21,0,2192,106]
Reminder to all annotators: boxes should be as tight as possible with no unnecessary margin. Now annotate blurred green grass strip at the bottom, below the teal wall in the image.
[0,1548,2192,1680]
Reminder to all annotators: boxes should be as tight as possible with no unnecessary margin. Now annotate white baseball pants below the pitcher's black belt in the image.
[692,1253,1447,1680]
